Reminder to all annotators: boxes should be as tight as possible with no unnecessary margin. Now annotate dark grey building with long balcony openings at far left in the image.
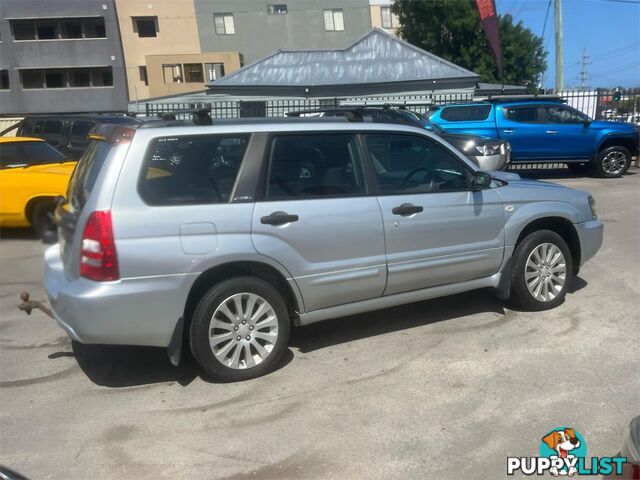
[0,0,127,115]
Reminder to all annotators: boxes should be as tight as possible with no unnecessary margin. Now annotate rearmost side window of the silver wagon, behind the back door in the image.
[140,135,249,205]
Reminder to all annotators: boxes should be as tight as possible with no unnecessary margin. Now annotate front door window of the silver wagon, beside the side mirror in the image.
[366,134,470,195]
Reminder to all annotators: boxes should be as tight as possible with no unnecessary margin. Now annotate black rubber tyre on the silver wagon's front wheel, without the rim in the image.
[510,230,574,311]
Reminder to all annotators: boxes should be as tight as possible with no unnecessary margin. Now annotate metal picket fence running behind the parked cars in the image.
[144,89,640,123]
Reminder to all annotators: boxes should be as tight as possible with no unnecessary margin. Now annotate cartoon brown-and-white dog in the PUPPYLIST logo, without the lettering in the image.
[540,427,587,477]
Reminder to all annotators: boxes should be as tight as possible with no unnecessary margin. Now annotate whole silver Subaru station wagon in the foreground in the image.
[45,119,603,380]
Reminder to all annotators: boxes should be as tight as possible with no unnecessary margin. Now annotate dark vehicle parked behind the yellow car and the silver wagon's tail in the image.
[0,114,141,158]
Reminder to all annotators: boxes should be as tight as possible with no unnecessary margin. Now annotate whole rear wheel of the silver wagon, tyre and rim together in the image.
[189,277,290,381]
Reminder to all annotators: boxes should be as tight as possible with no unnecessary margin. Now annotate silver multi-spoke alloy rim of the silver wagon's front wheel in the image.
[524,243,567,302]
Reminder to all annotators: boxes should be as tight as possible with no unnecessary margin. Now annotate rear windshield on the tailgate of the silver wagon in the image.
[67,140,111,210]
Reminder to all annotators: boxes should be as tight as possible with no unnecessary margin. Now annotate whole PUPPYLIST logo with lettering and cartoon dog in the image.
[507,427,627,477]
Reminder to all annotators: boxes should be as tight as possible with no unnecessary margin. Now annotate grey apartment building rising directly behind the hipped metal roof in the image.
[195,0,372,64]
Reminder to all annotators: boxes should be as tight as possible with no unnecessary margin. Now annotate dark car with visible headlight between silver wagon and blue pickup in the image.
[287,105,511,172]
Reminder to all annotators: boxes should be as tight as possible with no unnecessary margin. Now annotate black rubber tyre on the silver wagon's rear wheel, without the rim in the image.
[189,277,291,381]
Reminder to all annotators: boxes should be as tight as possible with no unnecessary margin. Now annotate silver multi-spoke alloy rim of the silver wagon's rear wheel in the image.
[209,293,278,369]
